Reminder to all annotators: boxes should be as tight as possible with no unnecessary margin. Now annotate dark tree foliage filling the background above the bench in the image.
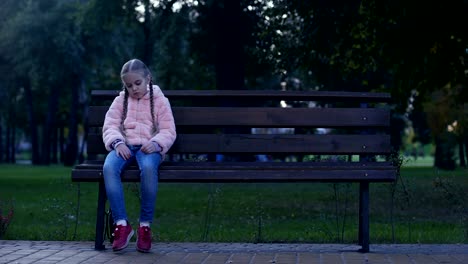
[0,0,468,167]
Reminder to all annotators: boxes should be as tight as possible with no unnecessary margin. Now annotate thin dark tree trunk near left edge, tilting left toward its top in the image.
[23,80,40,165]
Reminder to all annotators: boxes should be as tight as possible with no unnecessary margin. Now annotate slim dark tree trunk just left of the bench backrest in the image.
[63,75,82,166]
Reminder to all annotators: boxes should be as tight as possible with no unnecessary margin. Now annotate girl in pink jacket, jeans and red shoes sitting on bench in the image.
[102,59,176,252]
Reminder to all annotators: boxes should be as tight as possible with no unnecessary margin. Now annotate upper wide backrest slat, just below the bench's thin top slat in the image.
[89,106,390,128]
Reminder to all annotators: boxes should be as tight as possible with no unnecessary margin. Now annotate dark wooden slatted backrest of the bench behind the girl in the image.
[87,90,392,161]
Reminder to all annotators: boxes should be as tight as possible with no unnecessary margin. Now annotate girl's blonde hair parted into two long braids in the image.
[120,59,157,133]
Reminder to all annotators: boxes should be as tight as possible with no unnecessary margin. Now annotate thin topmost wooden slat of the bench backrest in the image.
[91,90,391,102]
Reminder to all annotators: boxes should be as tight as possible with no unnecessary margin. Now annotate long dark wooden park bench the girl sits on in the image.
[72,90,398,252]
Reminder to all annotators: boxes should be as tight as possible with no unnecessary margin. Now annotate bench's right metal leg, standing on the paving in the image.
[359,182,369,252]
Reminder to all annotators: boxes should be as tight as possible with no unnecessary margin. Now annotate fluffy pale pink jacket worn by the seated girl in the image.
[102,85,176,156]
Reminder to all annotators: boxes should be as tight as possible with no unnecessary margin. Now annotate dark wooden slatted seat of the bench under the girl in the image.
[72,163,396,182]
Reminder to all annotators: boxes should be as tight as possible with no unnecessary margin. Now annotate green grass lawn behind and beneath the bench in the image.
[0,162,468,243]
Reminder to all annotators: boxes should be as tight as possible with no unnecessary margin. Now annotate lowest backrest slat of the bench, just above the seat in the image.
[87,134,391,155]
